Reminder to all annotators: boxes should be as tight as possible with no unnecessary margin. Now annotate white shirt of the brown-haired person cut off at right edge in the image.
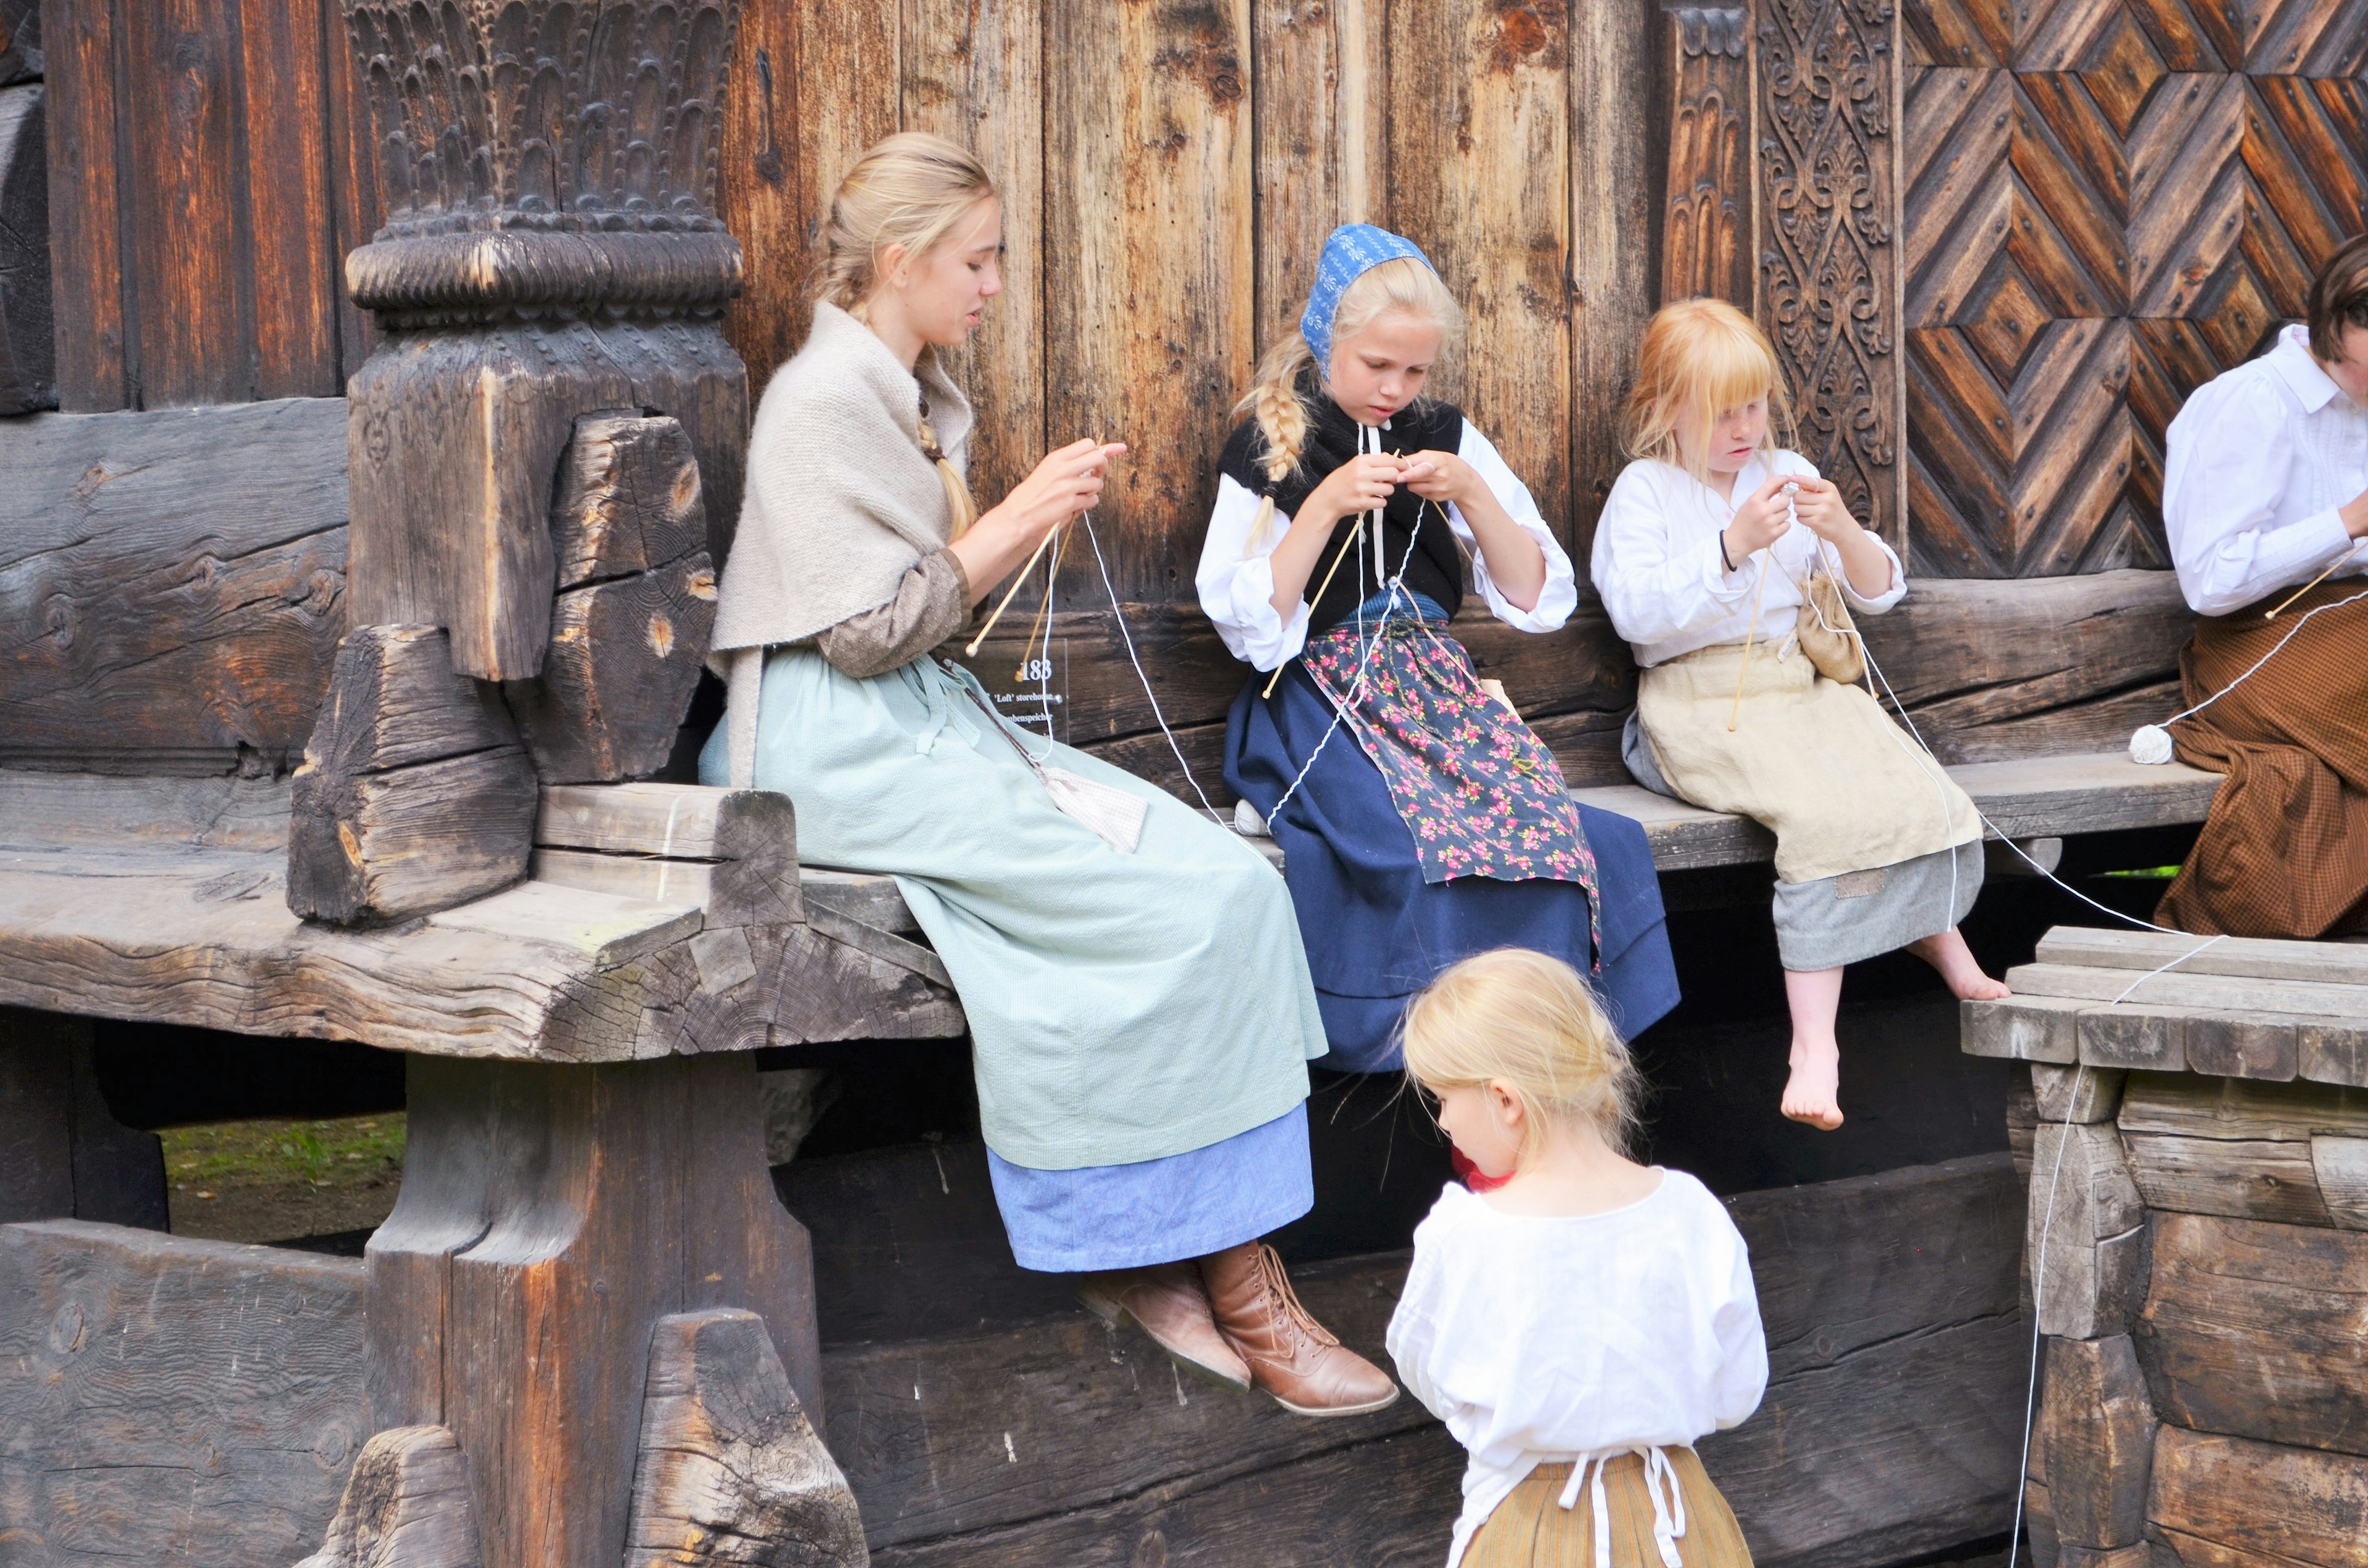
[2162,327,2368,616]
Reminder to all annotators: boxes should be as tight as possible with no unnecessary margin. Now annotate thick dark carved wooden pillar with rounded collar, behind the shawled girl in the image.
[343,0,748,679]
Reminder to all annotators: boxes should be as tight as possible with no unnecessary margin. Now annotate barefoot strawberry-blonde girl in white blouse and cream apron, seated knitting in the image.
[1591,298,2005,1130]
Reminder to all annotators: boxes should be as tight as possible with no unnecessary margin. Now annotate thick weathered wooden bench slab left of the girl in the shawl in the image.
[0,772,964,1061]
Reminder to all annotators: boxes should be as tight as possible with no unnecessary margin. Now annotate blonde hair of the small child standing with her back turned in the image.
[1402,948,1641,1158]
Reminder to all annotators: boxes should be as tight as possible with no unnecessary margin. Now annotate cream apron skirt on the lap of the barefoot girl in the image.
[1636,642,1982,881]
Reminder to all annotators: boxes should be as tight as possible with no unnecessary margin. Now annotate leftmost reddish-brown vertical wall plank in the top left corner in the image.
[43,0,130,412]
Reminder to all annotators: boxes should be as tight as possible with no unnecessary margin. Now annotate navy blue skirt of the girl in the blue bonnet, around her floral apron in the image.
[1224,644,1677,1073]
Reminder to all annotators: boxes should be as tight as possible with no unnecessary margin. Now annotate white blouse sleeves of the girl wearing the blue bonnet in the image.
[1193,419,1579,670]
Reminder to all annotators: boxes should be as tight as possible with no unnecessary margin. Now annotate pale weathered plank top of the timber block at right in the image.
[1963,926,2368,1087]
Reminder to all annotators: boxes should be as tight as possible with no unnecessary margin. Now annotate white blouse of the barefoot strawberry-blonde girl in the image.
[1589,453,1909,668]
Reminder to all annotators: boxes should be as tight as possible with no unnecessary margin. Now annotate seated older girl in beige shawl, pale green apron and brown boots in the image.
[701,133,1397,1416]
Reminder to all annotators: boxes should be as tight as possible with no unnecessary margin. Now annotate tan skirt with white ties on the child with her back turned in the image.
[1458,1447,1753,1568]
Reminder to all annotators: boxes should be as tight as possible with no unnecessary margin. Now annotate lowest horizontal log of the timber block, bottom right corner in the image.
[2145,1426,2368,1568]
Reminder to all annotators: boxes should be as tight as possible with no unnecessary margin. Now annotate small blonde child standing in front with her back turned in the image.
[1388,948,1769,1568]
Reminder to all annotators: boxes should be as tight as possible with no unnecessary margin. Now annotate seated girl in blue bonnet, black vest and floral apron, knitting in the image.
[1198,225,1677,1073]
